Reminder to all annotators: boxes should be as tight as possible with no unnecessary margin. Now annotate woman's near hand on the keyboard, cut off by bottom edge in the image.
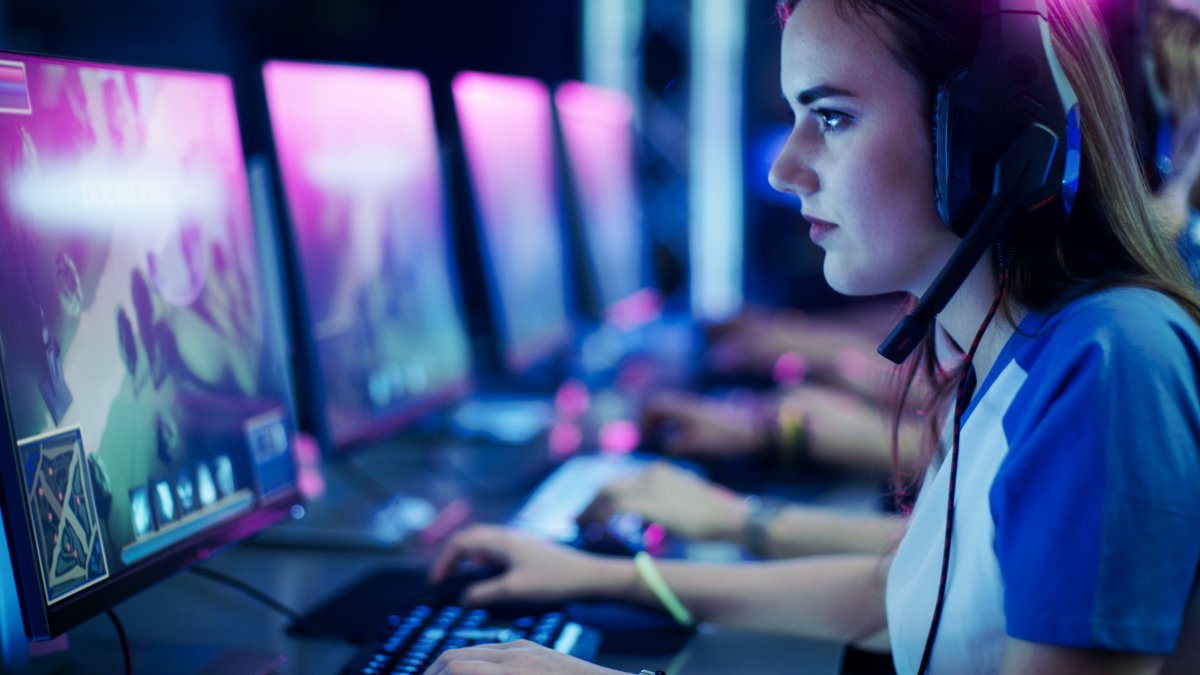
[425,640,620,675]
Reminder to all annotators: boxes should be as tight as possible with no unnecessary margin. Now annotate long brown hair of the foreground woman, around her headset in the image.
[779,0,1200,487]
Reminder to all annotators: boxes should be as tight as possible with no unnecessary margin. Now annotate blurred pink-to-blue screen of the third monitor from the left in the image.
[452,72,571,372]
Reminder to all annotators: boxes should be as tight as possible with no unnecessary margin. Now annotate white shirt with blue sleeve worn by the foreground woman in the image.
[887,288,1200,674]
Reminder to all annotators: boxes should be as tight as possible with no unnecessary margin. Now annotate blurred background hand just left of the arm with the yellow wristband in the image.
[642,393,769,460]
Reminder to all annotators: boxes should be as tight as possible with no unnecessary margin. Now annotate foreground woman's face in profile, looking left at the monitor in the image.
[770,0,959,295]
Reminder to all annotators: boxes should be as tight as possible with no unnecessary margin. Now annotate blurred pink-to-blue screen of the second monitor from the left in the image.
[263,61,470,447]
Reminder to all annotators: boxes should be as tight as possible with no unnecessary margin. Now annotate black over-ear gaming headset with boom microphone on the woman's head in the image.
[878,0,1080,364]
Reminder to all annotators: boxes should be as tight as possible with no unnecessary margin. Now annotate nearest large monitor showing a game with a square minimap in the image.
[0,54,296,638]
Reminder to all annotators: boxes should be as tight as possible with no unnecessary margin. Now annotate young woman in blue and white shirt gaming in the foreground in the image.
[431,0,1200,674]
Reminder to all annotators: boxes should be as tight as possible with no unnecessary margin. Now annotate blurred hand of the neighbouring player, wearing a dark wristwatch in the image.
[580,462,746,540]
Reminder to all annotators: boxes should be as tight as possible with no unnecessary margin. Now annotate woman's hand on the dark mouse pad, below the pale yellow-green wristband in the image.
[430,525,611,605]
